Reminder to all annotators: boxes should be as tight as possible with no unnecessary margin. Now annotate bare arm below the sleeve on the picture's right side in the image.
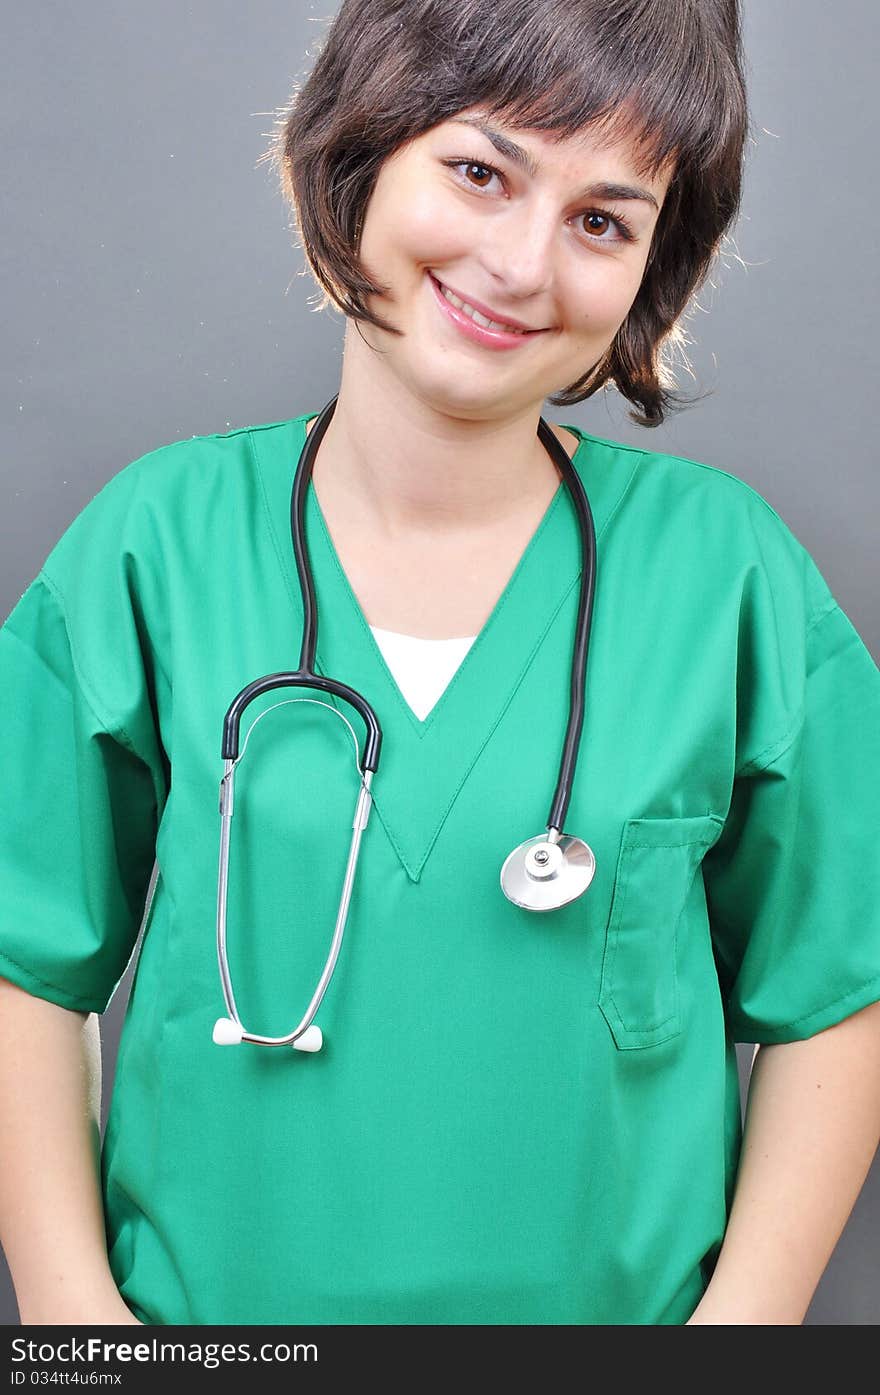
[689,1003,880,1325]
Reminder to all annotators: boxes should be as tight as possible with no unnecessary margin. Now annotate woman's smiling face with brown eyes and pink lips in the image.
[360,107,672,419]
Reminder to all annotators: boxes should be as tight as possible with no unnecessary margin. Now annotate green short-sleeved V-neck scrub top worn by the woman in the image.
[0,413,880,1324]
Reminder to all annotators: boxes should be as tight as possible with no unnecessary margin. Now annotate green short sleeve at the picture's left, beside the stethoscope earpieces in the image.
[0,477,169,1013]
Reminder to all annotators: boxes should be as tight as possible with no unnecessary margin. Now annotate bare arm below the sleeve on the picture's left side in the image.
[0,979,138,1324]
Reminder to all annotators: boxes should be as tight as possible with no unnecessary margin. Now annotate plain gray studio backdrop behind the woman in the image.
[0,0,880,1325]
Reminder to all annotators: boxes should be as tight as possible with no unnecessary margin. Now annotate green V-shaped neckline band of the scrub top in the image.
[250,412,640,882]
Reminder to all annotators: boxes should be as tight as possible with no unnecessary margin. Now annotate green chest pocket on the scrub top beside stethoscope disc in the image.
[598,815,724,1050]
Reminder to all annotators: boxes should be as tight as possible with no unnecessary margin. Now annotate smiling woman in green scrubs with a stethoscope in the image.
[0,0,880,1324]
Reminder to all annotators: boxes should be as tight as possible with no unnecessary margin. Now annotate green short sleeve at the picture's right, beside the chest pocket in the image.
[703,583,880,1043]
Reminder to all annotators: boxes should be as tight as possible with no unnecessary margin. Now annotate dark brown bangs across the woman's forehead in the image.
[431,0,742,177]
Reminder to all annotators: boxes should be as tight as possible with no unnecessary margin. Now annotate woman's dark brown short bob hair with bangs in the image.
[262,0,749,427]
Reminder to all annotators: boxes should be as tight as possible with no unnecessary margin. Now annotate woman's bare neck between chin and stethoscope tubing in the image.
[306,325,560,538]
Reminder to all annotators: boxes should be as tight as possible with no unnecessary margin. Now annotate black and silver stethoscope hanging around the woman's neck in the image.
[213,393,595,1052]
